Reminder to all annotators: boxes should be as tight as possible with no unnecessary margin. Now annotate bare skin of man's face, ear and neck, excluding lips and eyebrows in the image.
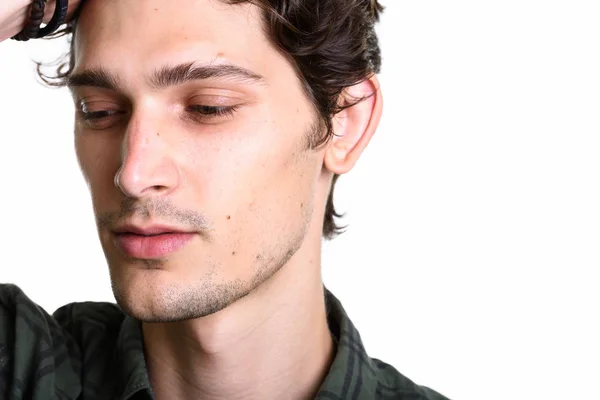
[71,0,382,399]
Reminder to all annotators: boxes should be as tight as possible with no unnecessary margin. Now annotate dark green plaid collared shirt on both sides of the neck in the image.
[0,285,447,400]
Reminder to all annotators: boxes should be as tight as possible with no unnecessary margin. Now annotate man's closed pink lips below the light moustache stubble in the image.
[114,226,196,259]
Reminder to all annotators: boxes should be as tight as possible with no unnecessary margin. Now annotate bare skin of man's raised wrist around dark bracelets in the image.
[0,0,81,42]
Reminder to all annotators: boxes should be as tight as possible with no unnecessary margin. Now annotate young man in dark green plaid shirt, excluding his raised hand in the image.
[0,0,444,400]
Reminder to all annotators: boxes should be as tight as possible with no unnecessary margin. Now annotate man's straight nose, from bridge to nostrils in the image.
[115,115,180,198]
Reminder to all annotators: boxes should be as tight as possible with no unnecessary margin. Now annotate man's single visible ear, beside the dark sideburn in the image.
[324,75,383,175]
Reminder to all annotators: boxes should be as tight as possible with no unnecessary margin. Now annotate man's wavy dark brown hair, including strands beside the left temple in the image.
[38,0,383,239]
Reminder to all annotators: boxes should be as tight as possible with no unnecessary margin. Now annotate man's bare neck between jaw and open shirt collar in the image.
[143,263,335,400]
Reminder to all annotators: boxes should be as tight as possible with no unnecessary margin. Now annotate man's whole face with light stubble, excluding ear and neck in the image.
[71,0,327,321]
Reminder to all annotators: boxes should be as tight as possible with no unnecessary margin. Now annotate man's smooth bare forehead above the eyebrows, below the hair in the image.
[74,0,273,81]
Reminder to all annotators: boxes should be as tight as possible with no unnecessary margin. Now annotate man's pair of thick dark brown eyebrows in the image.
[67,62,266,91]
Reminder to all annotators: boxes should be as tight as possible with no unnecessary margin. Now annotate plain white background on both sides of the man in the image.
[0,0,600,400]
